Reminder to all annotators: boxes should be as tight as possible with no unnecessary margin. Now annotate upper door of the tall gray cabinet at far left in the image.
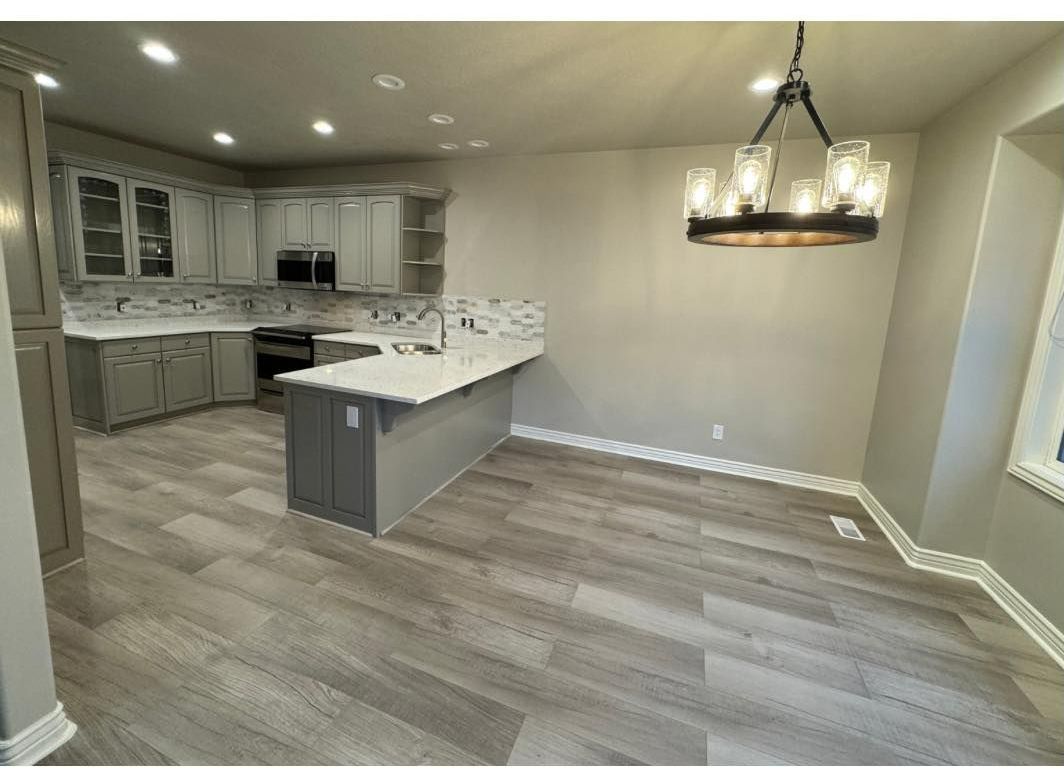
[0,70,60,330]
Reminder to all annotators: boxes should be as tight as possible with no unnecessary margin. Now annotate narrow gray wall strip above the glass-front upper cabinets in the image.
[45,121,244,185]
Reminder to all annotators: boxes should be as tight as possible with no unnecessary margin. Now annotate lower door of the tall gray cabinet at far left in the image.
[15,330,83,572]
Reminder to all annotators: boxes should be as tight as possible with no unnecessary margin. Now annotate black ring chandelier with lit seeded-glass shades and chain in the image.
[684,21,891,247]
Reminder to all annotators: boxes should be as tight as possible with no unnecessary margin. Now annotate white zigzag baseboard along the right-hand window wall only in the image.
[858,485,1064,668]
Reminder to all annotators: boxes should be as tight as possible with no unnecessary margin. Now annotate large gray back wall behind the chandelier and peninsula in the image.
[248,134,916,480]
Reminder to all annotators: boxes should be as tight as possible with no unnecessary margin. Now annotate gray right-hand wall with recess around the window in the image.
[863,36,1064,626]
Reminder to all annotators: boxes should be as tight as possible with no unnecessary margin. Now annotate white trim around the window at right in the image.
[1008,222,1064,502]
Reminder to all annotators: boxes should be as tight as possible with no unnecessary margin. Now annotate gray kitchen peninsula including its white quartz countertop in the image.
[277,332,543,536]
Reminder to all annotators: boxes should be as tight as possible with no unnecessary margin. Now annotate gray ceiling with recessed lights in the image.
[0,21,1064,169]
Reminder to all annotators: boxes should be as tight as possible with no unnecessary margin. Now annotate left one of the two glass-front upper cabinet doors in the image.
[69,169,133,282]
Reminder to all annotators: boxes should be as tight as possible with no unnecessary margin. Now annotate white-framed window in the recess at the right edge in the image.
[1009,221,1064,501]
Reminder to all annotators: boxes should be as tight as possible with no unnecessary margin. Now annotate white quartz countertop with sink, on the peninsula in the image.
[276,331,543,405]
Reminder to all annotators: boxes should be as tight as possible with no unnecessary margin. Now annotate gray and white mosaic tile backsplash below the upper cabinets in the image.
[60,282,547,340]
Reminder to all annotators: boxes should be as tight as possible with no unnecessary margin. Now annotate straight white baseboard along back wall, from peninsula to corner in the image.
[510,423,858,496]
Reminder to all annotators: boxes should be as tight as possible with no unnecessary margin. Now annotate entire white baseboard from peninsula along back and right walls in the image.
[510,423,1064,668]
